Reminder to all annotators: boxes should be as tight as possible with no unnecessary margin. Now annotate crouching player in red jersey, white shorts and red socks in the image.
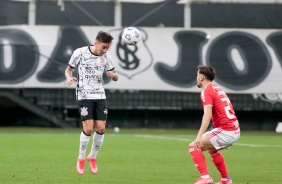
[189,65,240,184]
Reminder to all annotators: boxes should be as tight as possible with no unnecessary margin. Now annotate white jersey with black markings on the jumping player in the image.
[68,46,115,100]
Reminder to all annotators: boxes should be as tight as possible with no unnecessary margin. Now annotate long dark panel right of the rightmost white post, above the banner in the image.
[191,2,282,29]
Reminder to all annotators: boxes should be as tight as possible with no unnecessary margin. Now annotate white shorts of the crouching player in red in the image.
[204,128,240,150]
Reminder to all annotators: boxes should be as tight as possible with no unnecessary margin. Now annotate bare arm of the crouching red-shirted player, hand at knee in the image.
[194,105,212,149]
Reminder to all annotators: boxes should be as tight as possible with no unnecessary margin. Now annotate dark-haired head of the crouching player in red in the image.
[197,65,216,88]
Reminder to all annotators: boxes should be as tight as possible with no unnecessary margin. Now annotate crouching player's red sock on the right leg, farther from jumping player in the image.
[209,151,228,178]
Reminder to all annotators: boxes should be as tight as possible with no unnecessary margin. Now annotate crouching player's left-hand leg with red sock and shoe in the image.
[189,135,214,184]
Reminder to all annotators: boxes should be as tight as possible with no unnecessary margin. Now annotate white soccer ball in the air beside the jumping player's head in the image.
[121,27,141,45]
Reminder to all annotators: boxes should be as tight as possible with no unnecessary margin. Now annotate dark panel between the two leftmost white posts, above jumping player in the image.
[36,1,115,26]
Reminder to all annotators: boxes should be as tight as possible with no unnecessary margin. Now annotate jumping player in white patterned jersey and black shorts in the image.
[65,31,118,174]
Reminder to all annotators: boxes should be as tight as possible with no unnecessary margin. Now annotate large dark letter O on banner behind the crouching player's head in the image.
[206,31,272,90]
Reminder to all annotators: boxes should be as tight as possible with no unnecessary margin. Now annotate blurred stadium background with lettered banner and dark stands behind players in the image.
[0,0,282,130]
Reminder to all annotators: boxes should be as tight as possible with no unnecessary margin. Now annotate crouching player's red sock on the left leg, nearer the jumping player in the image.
[189,146,209,176]
